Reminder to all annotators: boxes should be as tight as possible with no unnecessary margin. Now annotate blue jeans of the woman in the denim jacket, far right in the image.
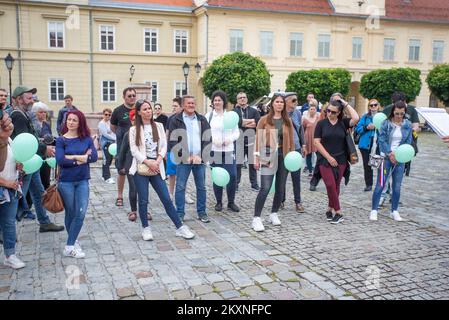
[371,158,405,211]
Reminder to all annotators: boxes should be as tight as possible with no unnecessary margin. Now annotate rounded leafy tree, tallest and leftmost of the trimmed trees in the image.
[203,52,271,104]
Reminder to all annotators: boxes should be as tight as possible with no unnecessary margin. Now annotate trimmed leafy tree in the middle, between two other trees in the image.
[285,68,351,105]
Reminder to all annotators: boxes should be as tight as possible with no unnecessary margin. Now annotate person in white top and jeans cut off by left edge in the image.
[0,130,25,269]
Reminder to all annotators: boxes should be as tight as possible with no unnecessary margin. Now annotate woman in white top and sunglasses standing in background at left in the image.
[98,108,116,183]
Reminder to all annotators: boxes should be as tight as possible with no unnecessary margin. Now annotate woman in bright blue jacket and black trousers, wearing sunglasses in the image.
[355,99,379,191]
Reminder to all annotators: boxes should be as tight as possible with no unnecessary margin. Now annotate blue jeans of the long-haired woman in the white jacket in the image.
[134,173,182,229]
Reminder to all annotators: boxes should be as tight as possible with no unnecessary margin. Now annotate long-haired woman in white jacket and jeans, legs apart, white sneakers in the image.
[129,100,195,241]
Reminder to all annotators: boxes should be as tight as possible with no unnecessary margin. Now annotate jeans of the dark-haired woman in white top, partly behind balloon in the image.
[211,152,237,204]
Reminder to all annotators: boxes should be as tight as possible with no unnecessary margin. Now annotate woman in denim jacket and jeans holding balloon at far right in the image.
[370,101,412,221]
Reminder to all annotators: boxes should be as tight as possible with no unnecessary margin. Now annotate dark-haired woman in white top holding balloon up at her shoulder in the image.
[206,90,240,212]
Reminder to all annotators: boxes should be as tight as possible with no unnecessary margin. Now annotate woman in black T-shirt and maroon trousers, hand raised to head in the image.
[314,93,359,224]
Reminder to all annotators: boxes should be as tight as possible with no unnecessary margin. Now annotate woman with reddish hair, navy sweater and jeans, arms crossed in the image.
[56,110,97,258]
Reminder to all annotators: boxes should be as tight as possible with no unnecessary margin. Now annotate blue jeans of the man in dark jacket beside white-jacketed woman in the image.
[175,163,206,219]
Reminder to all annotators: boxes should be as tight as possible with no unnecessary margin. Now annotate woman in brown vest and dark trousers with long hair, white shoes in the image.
[252,93,295,232]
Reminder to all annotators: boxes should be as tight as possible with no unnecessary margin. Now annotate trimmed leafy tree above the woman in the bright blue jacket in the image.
[360,68,421,106]
